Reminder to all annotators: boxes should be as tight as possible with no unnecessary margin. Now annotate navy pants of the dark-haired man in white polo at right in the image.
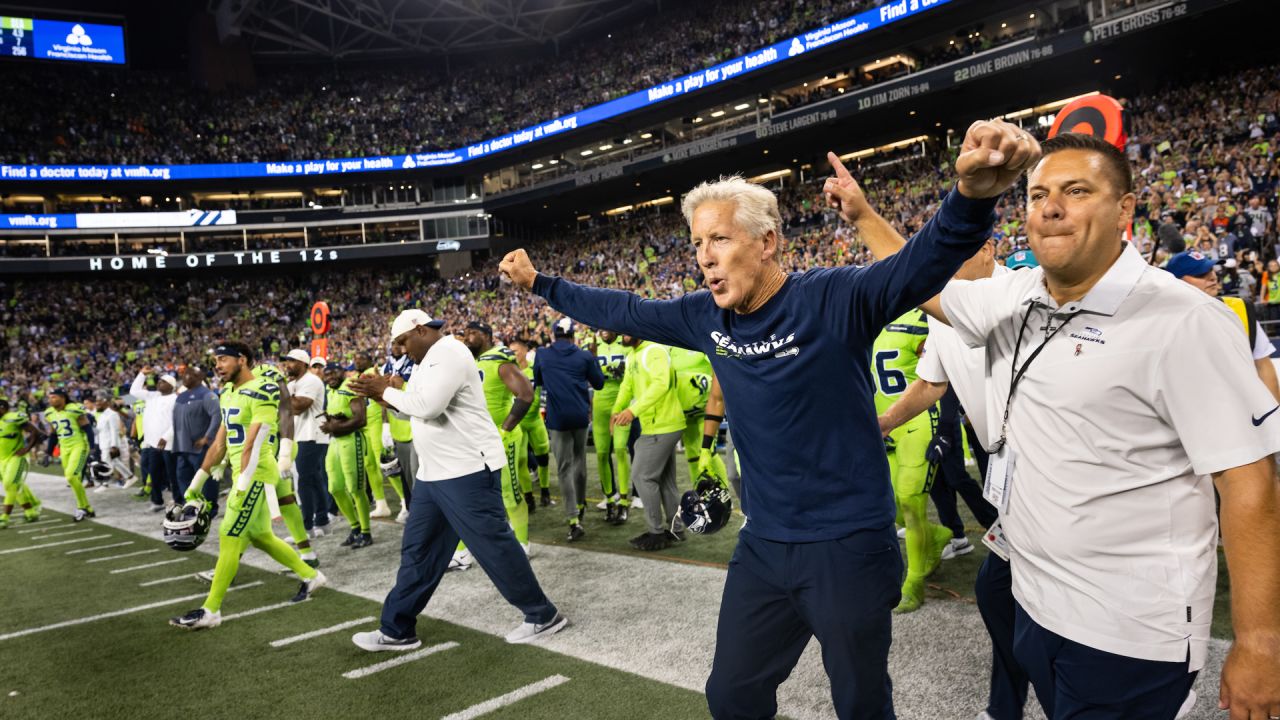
[1014,605,1196,720]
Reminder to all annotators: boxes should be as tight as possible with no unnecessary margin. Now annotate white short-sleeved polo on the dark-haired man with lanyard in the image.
[942,245,1280,670]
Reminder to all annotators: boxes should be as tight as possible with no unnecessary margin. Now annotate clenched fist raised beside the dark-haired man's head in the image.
[956,120,1041,199]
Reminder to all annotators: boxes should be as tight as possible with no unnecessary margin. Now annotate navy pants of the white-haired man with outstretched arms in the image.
[707,525,902,720]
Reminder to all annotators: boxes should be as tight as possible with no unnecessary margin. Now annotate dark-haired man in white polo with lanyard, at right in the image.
[927,133,1280,720]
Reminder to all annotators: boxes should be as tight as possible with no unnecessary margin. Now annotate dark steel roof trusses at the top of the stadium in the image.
[209,0,658,60]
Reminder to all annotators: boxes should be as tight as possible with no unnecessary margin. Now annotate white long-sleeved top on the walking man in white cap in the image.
[383,336,507,482]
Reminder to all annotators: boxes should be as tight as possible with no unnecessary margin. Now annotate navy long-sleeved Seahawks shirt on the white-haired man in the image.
[534,191,996,542]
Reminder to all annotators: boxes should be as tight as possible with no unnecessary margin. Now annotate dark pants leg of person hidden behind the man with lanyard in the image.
[973,552,1029,720]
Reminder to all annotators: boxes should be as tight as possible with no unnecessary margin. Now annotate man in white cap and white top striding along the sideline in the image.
[351,304,568,652]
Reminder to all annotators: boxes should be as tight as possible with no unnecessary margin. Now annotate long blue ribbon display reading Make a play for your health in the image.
[0,0,951,182]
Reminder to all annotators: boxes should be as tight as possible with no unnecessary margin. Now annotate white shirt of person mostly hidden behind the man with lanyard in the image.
[915,264,1014,447]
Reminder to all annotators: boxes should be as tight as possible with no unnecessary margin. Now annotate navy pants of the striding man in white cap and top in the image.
[381,469,556,638]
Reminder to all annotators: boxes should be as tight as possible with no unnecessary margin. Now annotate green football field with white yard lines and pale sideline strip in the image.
[0,453,1230,720]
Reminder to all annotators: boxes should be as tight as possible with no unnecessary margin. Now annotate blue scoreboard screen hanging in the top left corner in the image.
[0,17,124,65]
